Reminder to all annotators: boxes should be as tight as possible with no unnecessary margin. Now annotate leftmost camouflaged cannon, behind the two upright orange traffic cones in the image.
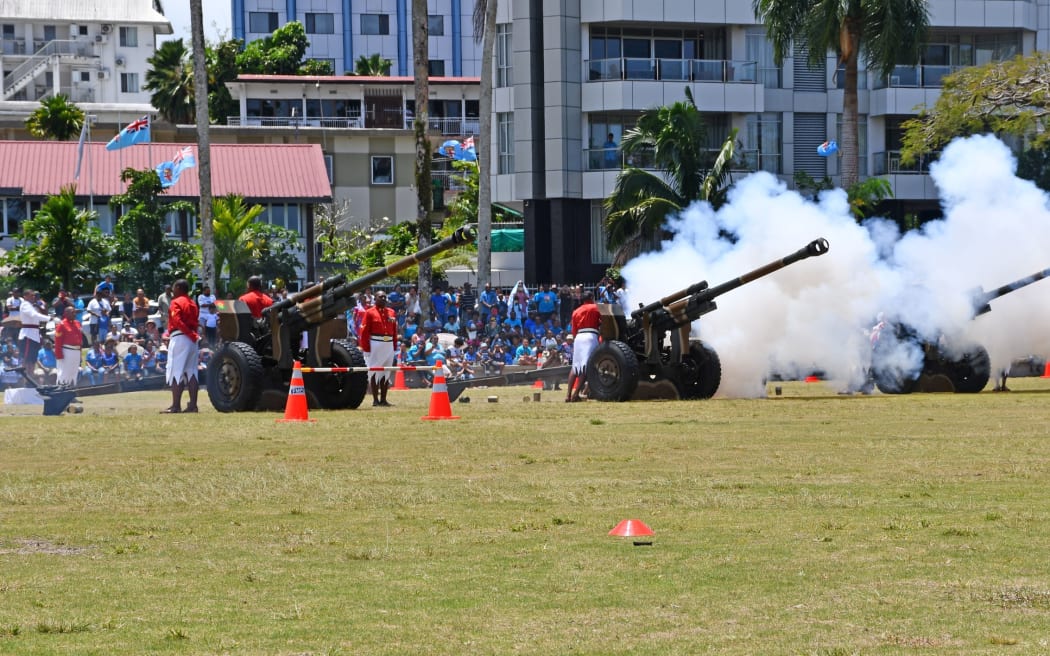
[207,227,477,412]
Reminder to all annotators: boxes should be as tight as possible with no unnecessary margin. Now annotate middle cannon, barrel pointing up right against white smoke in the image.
[587,239,830,401]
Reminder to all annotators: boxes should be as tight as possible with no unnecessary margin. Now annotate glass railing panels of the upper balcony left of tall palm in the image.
[587,57,758,84]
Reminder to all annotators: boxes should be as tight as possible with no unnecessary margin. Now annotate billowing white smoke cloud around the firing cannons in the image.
[623,136,1050,397]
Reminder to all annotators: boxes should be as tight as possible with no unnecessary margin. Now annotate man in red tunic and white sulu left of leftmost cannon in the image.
[162,278,201,415]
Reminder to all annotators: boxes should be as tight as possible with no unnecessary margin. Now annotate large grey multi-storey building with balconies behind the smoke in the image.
[490,0,1050,281]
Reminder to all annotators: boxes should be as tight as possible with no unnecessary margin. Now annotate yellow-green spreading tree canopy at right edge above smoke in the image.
[901,51,1050,163]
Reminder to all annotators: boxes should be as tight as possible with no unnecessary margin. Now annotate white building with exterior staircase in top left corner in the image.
[0,0,171,104]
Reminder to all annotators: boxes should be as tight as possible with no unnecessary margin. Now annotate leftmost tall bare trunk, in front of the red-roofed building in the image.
[190,0,217,290]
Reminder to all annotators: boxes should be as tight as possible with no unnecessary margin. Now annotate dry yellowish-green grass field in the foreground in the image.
[0,379,1050,655]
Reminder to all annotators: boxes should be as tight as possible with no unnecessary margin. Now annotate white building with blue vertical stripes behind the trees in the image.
[232,0,481,78]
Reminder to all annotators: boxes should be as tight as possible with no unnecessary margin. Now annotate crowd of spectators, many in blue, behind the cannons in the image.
[0,276,623,387]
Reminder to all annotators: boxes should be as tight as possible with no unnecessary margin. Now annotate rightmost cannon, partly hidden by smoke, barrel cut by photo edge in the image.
[870,264,1050,394]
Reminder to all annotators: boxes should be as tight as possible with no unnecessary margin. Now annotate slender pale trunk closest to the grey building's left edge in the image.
[477,0,497,293]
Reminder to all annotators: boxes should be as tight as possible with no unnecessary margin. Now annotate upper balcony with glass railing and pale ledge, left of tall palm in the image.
[583,58,765,113]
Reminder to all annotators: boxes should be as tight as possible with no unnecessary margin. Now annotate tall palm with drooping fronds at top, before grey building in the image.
[752,0,929,189]
